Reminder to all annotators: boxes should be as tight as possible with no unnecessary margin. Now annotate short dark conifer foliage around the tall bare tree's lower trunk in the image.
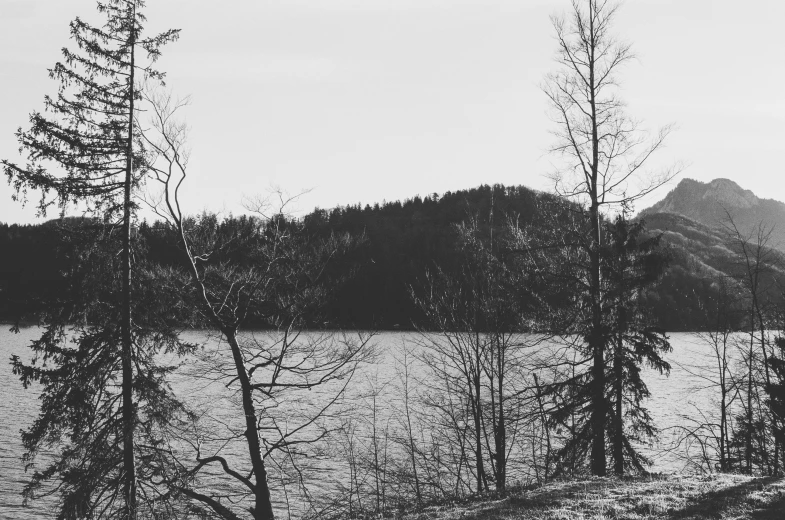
[550,216,670,475]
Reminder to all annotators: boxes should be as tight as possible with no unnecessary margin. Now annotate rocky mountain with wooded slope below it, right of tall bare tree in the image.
[638,179,785,330]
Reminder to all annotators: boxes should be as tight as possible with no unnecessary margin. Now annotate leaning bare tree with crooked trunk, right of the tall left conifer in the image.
[143,91,370,520]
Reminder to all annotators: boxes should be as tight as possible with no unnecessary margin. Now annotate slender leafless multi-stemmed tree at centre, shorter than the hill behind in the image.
[413,213,541,493]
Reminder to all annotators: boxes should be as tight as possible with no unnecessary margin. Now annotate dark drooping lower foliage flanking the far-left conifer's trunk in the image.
[12,220,191,518]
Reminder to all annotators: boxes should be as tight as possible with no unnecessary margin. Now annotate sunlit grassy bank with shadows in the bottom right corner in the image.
[401,475,785,520]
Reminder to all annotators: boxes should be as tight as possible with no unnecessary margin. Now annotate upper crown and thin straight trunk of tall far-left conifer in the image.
[2,0,179,518]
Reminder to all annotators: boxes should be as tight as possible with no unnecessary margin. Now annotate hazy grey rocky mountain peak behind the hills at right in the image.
[640,179,785,251]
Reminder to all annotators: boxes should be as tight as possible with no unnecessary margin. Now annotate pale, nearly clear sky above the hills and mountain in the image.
[0,0,785,223]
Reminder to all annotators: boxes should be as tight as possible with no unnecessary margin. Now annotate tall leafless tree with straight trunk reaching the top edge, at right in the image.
[543,0,678,475]
